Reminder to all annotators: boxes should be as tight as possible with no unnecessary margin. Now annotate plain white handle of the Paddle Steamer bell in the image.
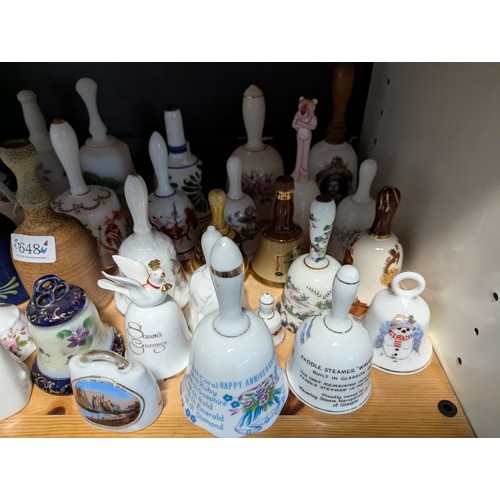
[325,264,359,333]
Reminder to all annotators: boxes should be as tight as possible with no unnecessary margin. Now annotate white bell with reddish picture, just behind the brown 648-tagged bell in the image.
[50,120,128,269]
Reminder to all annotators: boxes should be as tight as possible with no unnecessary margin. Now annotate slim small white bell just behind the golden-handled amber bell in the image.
[224,156,260,261]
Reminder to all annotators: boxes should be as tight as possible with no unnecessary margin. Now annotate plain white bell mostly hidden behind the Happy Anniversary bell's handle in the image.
[186,226,222,332]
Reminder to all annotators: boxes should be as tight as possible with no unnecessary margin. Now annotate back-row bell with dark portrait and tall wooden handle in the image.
[309,63,358,206]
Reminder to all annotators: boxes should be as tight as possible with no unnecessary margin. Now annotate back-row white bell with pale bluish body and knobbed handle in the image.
[75,78,135,194]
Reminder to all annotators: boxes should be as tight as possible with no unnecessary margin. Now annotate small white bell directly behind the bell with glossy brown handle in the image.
[327,159,377,262]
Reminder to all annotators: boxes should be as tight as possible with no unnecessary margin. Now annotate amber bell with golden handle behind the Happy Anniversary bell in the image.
[188,189,248,273]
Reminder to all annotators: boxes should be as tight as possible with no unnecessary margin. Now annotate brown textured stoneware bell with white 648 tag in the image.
[0,139,113,311]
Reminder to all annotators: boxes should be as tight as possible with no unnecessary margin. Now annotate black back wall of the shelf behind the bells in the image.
[0,62,372,193]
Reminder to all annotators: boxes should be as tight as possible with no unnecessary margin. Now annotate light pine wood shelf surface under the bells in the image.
[0,275,475,438]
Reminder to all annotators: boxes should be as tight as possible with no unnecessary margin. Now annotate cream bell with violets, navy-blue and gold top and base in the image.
[26,275,123,395]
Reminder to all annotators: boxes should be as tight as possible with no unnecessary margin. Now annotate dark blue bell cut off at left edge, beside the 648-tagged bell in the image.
[0,214,29,306]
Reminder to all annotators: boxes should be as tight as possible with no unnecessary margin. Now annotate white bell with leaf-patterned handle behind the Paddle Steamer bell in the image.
[279,194,340,333]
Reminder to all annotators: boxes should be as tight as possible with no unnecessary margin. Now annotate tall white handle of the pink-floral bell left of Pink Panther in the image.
[242,85,266,151]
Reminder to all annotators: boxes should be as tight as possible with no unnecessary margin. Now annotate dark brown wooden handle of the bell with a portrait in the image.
[325,63,354,144]
